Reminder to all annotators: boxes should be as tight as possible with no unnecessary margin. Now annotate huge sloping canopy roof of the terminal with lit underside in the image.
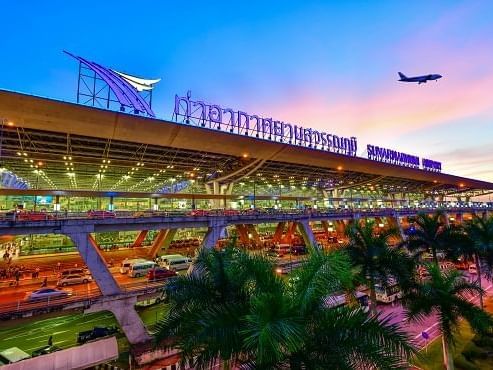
[0,90,493,195]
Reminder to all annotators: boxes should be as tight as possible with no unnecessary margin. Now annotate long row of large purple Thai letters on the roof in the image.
[173,92,358,157]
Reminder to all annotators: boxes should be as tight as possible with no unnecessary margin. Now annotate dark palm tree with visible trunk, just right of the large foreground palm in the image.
[346,221,414,314]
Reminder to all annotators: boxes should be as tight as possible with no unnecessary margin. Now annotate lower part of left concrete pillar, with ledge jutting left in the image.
[84,297,152,345]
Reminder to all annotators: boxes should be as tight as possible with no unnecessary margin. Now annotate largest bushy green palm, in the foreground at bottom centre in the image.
[155,241,415,369]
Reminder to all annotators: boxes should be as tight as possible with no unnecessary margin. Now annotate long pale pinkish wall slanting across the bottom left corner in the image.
[0,337,118,370]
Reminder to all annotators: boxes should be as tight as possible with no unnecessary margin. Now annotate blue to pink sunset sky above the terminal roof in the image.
[0,0,493,181]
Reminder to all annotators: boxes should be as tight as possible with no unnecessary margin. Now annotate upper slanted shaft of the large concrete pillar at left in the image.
[65,232,121,295]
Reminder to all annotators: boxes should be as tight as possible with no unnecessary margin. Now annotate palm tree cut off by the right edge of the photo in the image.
[462,215,493,308]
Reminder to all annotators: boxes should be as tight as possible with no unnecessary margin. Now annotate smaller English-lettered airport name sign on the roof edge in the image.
[366,144,442,172]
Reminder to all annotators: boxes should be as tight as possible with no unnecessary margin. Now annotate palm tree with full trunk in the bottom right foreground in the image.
[404,264,493,370]
